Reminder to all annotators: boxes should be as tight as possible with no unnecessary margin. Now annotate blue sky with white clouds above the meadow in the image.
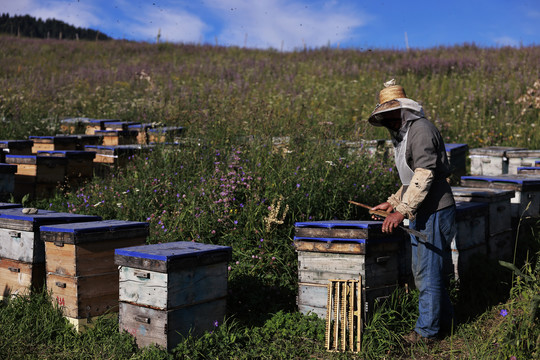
[0,0,540,51]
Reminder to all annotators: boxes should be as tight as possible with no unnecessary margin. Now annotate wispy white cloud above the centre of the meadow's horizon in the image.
[206,0,365,50]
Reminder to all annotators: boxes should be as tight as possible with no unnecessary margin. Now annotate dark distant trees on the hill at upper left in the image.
[0,13,111,40]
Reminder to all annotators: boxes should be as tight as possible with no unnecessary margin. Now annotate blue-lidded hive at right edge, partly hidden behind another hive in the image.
[461,174,540,219]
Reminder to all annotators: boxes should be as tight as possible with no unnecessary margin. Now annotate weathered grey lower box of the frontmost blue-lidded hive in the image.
[119,299,227,350]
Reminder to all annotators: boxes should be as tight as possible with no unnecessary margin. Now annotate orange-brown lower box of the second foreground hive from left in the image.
[47,271,118,319]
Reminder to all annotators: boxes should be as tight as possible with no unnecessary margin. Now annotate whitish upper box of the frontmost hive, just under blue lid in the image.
[119,262,228,310]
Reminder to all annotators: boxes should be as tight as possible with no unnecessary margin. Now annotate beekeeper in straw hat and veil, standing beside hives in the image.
[368,81,456,343]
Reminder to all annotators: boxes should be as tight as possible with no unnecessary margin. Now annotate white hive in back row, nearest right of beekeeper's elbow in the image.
[469,146,526,175]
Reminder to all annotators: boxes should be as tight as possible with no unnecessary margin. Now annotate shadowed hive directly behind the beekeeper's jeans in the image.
[450,201,488,279]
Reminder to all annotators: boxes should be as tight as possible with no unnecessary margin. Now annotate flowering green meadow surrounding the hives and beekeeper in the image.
[0,36,540,359]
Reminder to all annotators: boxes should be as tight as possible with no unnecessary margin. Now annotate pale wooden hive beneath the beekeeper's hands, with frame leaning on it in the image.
[294,220,402,318]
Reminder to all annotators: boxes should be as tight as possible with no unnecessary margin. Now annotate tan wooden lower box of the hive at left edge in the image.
[0,259,45,298]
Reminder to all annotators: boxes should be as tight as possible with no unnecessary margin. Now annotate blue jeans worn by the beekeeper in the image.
[409,206,456,338]
